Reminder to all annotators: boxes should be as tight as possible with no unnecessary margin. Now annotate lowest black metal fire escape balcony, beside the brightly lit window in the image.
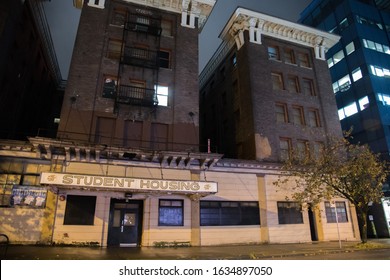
[116,85,158,106]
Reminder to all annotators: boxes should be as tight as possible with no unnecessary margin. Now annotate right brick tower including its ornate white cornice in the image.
[200,9,341,162]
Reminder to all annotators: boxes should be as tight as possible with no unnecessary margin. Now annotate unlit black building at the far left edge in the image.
[0,0,64,140]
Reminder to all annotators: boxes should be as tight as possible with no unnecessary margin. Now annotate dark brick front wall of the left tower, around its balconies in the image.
[59,0,199,150]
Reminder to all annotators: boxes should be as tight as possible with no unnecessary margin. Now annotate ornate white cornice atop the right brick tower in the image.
[219,8,340,60]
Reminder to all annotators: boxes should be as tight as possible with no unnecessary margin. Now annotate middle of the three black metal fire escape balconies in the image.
[121,47,158,68]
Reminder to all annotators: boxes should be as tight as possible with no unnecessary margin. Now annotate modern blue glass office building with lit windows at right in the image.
[299,0,390,237]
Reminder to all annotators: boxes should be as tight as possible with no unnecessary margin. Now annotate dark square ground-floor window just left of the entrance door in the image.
[64,195,96,225]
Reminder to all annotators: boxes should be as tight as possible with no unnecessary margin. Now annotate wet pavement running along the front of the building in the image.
[1,239,390,260]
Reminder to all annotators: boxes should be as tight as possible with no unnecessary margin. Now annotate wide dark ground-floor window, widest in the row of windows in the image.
[200,200,260,226]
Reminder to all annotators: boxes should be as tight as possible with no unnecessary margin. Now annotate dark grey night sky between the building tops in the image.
[44,0,311,80]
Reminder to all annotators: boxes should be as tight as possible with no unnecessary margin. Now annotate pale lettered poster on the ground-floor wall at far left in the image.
[11,186,47,208]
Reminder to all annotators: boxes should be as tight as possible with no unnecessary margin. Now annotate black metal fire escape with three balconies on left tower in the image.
[114,14,161,110]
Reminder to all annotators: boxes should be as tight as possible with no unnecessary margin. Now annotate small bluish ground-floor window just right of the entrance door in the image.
[158,199,184,226]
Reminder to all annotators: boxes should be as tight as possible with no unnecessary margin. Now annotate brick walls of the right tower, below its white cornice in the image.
[200,32,341,161]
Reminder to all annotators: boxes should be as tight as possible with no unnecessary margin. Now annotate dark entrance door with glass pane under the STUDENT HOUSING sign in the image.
[107,199,143,247]
